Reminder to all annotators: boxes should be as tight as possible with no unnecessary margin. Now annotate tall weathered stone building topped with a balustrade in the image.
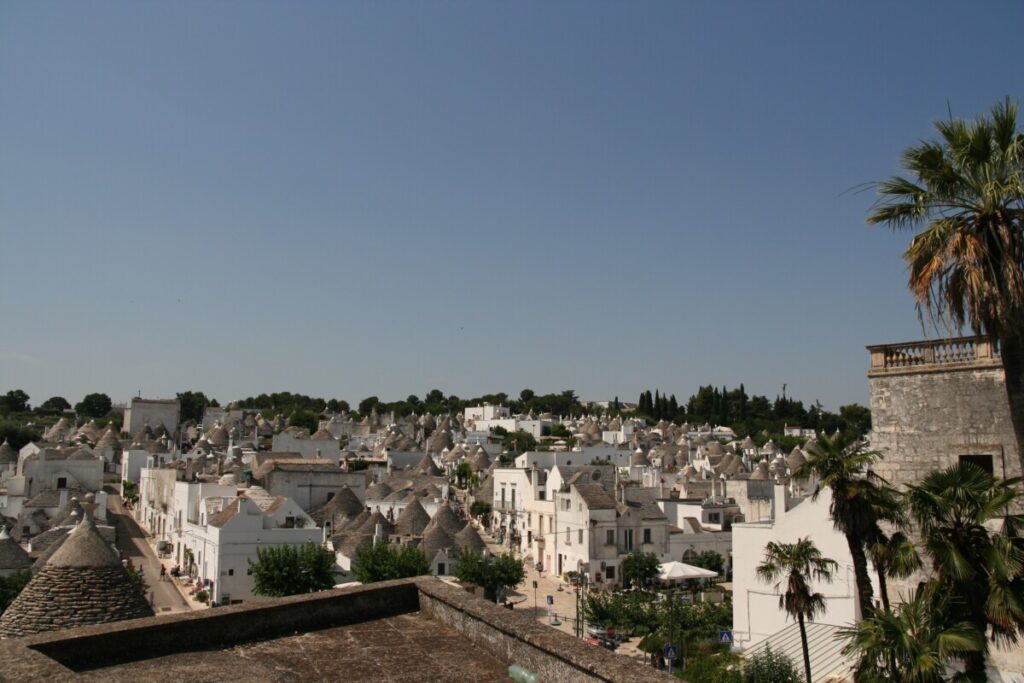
[867,337,1021,487]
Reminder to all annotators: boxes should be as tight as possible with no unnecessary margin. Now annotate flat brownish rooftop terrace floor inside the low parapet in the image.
[72,613,510,683]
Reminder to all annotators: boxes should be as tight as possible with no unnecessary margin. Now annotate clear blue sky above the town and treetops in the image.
[0,0,1024,410]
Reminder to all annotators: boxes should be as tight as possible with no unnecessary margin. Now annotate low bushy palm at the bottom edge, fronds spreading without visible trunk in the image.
[840,584,985,683]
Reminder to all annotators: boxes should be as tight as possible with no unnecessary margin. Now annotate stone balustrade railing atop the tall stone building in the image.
[867,337,1001,375]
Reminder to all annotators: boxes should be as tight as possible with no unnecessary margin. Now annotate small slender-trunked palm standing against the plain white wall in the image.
[757,537,837,683]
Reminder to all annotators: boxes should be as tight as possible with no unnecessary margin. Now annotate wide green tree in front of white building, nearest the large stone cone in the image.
[249,542,334,597]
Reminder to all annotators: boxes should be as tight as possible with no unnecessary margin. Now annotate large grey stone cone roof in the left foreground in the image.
[0,503,153,638]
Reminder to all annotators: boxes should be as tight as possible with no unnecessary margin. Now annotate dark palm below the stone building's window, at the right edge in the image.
[907,465,1024,680]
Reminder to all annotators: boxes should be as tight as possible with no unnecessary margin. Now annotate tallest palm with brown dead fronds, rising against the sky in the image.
[867,98,1024,471]
